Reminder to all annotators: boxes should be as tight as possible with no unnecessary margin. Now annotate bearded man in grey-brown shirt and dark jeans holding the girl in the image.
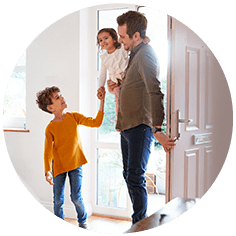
[98,11,175,224]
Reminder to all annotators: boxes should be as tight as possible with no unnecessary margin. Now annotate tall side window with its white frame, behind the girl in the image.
[92,4,135,218]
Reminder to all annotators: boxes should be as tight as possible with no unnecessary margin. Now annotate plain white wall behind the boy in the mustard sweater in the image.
[4,9,95,218]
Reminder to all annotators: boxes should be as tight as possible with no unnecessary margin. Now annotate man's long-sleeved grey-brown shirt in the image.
[116,43,164,131]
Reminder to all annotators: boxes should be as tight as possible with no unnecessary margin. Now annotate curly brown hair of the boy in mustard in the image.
[36,86,60,114]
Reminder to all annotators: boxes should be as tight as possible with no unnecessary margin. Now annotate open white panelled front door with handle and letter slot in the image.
[168,18,233,200]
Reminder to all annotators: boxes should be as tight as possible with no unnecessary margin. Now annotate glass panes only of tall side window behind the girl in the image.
[97,8,128,209]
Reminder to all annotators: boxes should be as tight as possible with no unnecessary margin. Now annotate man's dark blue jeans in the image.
[121,124,153,224]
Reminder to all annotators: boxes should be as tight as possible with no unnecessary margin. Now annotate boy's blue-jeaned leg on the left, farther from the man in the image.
[53,173,66,220]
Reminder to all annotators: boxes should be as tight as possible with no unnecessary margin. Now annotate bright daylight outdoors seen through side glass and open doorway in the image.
[97,7,168,214]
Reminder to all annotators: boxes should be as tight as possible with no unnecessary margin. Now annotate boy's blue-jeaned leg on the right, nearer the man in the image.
[68,166,87,223]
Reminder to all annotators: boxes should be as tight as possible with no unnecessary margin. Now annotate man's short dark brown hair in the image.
[116,11,147,39]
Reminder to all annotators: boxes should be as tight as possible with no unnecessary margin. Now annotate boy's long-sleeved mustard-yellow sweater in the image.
[44,110,104,177]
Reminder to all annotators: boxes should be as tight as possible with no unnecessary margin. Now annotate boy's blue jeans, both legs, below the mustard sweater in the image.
[53,166,87,223]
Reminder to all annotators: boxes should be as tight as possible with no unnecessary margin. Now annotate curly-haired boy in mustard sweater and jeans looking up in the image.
[36,86,105,229]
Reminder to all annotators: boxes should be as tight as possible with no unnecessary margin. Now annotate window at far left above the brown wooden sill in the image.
[3,51,26,129]
